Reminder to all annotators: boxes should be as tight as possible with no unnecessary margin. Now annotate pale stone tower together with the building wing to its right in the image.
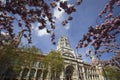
[57,36,103,80]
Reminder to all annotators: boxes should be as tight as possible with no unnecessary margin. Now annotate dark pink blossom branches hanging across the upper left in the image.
[0,0,81,44]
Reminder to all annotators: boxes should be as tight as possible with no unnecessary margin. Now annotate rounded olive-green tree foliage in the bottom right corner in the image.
[103,66,120,80]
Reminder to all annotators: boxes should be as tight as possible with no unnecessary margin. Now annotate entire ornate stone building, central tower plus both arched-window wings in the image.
[1,36,104,80]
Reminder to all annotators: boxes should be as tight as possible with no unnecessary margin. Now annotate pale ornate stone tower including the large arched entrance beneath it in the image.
[57,35,82,80]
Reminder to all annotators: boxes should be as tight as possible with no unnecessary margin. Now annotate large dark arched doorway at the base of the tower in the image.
[65,65,74,80]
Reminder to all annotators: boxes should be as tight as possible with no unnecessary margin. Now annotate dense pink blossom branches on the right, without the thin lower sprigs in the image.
[76,0,120,52]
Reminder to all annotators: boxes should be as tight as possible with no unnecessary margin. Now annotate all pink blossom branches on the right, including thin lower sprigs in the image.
[76,0,120,63]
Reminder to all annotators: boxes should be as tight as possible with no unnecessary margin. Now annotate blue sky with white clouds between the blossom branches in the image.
[19,0,118,62]
